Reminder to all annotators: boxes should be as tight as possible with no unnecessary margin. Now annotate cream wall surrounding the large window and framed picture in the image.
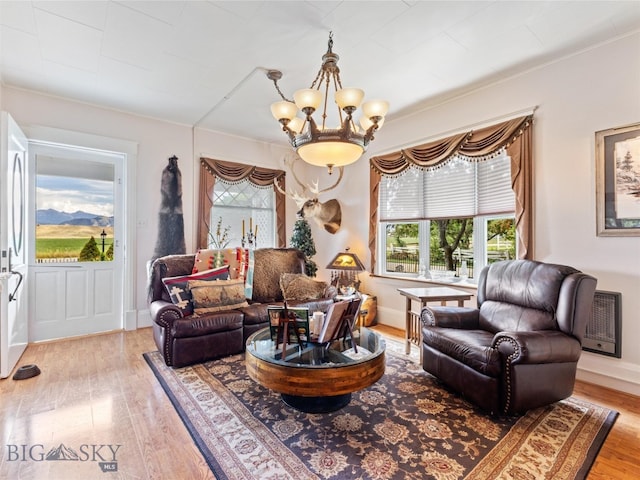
[336,33,640,394]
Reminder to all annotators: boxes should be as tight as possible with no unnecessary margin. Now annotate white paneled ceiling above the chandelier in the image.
[0,0,640,144]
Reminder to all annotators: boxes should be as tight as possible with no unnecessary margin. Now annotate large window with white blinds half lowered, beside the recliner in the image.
[378,150,516,281]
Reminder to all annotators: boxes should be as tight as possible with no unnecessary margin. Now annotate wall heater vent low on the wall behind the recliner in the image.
[582,290,622,358]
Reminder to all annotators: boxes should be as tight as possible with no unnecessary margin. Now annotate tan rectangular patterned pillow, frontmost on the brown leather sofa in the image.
[189,278,249,315]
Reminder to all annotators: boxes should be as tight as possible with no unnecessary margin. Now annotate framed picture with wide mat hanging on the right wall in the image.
[596,123,640,237]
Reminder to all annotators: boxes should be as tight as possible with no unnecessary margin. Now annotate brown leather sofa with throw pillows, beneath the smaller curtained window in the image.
[148,248,337,367]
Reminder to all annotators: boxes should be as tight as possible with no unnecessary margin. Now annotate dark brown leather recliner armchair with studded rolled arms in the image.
[421,260,596,415]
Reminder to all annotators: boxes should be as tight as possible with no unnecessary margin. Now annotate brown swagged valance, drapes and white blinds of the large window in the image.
[369,115,533,273]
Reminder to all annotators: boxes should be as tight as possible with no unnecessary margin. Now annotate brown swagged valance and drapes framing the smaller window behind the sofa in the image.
[197,157,287,248]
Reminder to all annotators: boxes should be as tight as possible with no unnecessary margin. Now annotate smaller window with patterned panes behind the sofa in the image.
[208,180,275,248]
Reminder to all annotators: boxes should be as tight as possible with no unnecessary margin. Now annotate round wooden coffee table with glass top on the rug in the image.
[245,328,385,413]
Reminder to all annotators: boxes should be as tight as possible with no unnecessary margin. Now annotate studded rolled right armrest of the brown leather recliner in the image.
[492,330,582,364]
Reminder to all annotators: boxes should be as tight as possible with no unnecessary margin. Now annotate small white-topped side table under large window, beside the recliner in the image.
[398,287,473,363]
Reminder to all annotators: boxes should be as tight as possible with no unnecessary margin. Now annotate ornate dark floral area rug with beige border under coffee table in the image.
[144,341,617,480]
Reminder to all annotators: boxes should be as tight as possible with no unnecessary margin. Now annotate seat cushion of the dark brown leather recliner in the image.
[422,327,502,377]
